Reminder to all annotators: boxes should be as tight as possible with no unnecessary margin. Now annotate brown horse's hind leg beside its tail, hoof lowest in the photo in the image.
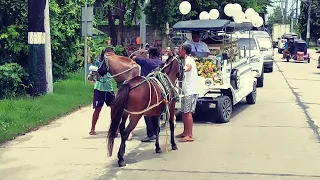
[118,115,142,167]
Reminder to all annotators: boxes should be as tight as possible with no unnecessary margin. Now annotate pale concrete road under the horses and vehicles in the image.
[0,49,320,180]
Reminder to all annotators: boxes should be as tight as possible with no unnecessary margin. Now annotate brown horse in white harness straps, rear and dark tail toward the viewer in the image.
[108,56,184,167]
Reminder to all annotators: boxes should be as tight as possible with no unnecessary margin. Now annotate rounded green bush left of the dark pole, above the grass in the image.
[0,63,28,98]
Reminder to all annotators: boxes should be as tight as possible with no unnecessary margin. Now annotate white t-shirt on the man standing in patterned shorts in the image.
[183,56,200,96]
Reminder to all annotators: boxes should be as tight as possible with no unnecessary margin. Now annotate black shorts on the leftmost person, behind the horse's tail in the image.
[93,89,115,109]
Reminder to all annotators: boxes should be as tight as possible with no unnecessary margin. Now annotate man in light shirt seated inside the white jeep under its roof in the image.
[185,31,210,57]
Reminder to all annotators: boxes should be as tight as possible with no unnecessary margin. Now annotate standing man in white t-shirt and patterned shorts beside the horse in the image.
[177,44,199,142]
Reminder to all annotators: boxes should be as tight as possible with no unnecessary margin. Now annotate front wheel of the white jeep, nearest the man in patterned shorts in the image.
[217,96,232,123]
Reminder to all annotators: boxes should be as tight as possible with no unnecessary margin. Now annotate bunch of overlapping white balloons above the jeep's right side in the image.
[224,3,263,27]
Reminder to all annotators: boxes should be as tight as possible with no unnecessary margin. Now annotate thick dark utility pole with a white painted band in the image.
[28,0,47,96]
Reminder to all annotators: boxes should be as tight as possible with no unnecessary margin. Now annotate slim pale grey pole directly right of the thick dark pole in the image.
[44,0,53,94]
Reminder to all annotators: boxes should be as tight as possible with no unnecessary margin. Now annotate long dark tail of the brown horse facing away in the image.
[107,83,130,157]
